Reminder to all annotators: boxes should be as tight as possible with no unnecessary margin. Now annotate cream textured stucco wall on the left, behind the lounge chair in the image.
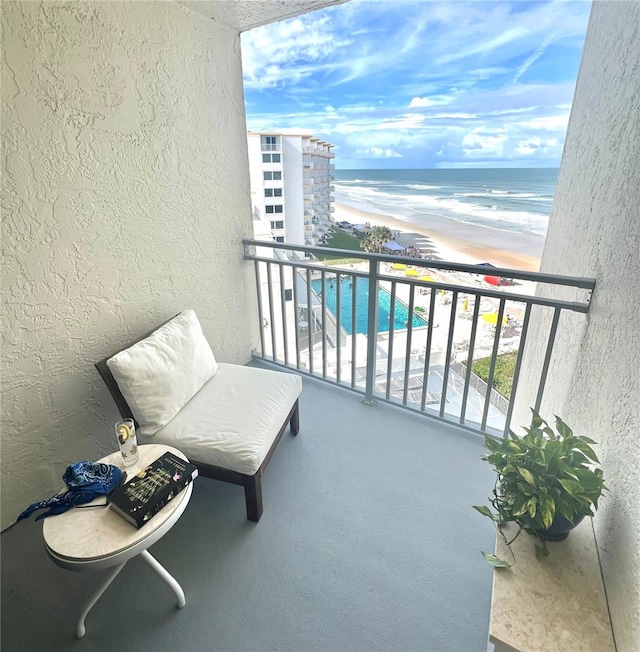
[1,2,259,528]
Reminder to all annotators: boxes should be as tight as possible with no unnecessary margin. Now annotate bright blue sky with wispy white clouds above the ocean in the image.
[242,0,591,168]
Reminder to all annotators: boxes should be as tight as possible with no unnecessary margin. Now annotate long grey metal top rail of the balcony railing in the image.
[242,239,596,290]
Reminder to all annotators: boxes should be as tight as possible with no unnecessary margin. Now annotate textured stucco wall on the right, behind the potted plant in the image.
[516,1,640,652]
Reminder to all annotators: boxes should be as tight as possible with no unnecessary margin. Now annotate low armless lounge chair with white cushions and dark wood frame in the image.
[95,310,302,522]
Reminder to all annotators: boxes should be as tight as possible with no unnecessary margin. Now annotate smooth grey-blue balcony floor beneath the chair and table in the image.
[2,364,494,652]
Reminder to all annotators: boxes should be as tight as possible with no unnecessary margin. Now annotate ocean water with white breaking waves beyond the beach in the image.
[335,168,558,236]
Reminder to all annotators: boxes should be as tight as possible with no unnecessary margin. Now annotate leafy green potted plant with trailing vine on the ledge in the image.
[473,409,606,568]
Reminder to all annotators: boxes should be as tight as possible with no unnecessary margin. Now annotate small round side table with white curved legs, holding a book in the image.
[42,444,193,638]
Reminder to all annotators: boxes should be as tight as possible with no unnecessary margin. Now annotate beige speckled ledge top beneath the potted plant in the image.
[489,519,615,652]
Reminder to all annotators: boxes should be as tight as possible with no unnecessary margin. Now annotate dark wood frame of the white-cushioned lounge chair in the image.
[95,320,300,523]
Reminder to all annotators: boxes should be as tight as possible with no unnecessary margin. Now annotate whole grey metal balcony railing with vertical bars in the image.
[244,240,596,435]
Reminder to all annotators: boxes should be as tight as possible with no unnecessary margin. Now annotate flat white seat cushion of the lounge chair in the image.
[141,363,302,475]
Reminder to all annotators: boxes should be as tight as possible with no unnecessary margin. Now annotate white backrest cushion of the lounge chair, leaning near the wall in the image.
[107,310,218,437]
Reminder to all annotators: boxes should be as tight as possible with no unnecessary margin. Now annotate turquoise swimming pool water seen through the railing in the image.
[311,277,427,335]
